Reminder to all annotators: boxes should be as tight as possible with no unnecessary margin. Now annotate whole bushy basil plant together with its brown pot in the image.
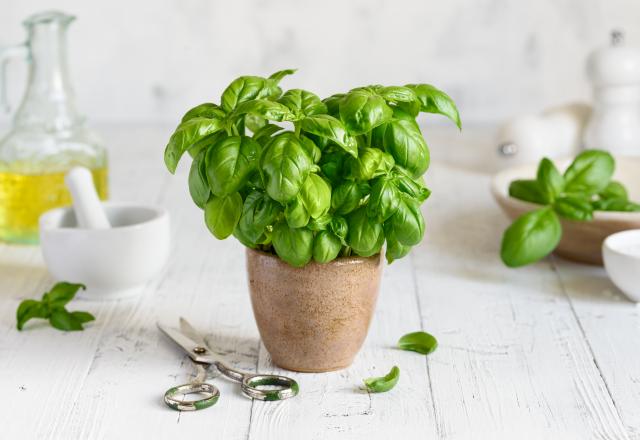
[164,70,460,371]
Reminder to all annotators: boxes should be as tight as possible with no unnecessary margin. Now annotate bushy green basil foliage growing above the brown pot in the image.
[164,70,460,267]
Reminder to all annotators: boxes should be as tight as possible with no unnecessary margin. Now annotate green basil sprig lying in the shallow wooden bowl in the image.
[500,150,640,267]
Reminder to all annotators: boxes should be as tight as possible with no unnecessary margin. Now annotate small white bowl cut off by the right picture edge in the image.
[602,229,640,302]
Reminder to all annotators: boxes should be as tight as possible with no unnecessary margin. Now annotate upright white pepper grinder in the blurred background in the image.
[584,31,640,156]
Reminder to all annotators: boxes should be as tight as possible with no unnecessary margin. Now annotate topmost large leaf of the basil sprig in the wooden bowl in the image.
[564,150,615,195]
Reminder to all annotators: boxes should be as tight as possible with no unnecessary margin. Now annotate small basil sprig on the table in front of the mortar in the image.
[16,282,95,331]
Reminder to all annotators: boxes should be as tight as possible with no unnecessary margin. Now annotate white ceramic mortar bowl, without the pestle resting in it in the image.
[40,202,170,300]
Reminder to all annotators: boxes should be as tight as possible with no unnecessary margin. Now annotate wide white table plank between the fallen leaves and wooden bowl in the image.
[413,167,628,439]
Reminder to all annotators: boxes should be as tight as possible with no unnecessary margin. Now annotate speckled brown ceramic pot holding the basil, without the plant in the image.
[247,249,382,372]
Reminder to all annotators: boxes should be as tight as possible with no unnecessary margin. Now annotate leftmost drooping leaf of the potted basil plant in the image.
[164,117,224,173]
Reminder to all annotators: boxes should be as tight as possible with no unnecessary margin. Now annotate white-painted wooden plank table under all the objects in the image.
[0,127,640,440]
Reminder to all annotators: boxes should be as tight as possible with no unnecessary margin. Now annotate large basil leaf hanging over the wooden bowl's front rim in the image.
[500,206,562,267]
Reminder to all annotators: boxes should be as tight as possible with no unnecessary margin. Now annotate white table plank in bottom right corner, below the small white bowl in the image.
[554,258,640,439]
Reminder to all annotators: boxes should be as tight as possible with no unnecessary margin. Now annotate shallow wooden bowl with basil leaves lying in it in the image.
[491,157,640,265]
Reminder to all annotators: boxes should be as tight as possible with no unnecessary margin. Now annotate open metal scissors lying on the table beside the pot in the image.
[157,318,299,411]
